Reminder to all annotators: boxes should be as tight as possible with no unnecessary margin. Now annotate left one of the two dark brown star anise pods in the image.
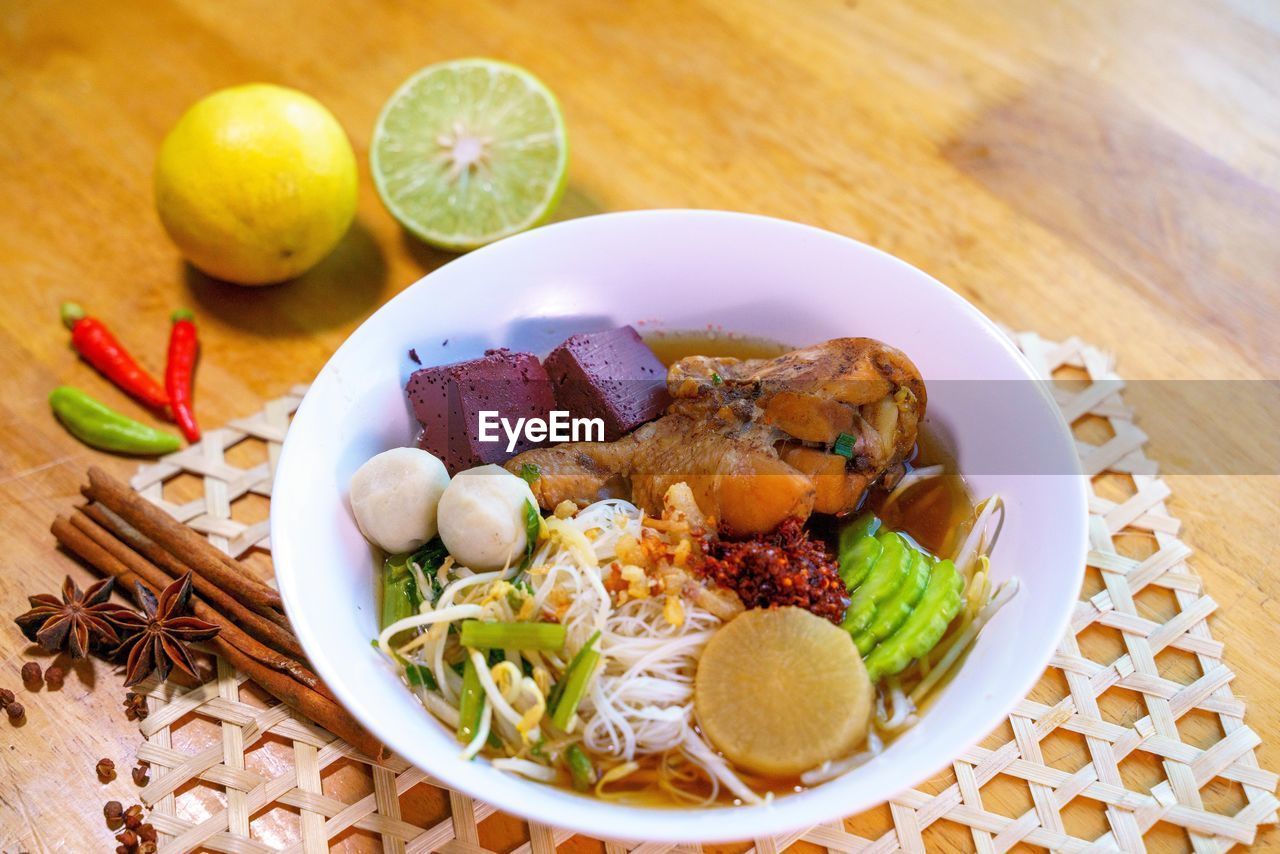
[14,575,133,658]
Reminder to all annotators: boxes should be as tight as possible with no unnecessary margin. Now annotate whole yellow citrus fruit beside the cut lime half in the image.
[155,83,357,284]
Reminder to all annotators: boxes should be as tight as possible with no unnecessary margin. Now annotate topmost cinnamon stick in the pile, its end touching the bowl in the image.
[86,466,284,616]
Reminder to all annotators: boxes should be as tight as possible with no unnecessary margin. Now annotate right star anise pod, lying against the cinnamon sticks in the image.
[116,572,221,688]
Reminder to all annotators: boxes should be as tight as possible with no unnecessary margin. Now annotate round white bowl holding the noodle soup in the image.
[271,210,1087,842]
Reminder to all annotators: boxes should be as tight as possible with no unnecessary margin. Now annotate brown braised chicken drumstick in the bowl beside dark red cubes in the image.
[506,338,925,535]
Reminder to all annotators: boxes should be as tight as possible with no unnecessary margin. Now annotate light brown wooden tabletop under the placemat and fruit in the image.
[0,0,1280,850]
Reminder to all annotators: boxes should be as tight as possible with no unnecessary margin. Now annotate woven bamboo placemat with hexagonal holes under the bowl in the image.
[122,333,1277,854]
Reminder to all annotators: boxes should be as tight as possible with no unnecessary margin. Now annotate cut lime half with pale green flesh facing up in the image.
[370,59,568,251]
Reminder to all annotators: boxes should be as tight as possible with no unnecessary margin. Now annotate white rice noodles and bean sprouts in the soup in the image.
[378,483,1016,804]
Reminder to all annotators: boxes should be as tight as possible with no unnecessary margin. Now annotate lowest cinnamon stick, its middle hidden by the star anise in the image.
[51,516,383,761]
